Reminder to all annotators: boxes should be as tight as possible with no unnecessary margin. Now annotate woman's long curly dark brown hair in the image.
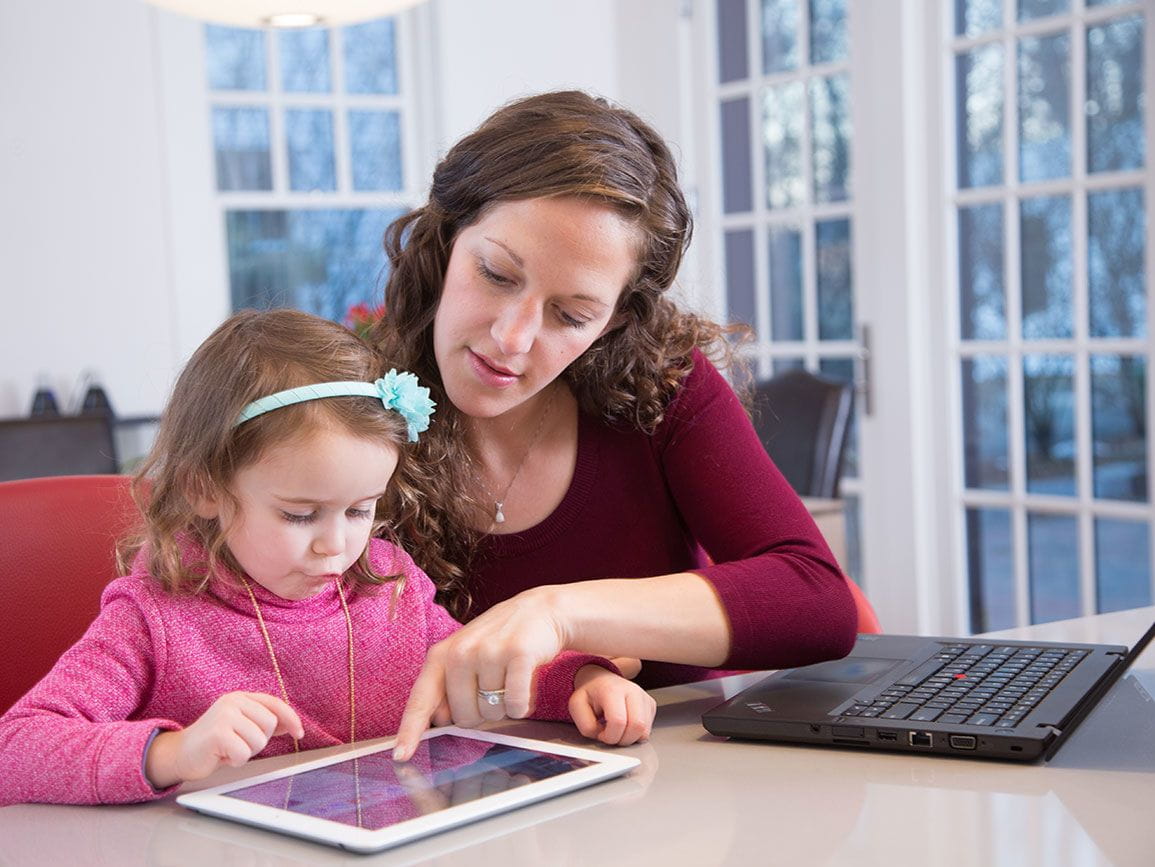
[377,91,735,619]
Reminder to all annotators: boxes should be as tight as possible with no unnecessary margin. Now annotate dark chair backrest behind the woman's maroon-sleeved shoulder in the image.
[752,369,854,498]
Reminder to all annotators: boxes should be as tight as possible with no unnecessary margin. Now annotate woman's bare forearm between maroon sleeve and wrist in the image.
[542,573,730,667]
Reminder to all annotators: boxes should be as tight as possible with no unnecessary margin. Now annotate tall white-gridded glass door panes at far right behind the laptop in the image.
[948,0,1153,631]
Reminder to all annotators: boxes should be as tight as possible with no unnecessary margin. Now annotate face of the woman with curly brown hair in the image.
[433,197,639,418]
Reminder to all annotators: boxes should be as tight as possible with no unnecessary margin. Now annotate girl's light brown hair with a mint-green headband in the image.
[118,309,408,592]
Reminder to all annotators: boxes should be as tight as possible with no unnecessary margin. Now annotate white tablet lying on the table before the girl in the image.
[177,727,640,852]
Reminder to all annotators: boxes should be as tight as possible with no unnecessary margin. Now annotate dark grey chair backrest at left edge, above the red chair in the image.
[0,413,118,481]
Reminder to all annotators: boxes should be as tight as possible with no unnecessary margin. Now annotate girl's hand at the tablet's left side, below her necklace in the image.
[144,693,305,788]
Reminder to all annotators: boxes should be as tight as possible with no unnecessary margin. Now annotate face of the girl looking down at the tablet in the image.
[209,428,398,599]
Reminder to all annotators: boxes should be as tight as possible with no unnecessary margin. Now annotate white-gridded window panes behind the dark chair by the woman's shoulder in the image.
[711,0,863,582]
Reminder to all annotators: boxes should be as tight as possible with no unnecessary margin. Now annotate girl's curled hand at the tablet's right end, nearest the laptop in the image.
[569,665,657,747]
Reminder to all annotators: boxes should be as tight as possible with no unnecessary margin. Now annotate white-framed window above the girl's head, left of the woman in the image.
[204,16,417,321]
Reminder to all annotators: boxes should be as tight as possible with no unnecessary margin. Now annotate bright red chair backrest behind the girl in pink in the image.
[0,476,139,713]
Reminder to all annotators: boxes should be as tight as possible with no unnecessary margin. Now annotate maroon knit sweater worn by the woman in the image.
[469,353,857,688]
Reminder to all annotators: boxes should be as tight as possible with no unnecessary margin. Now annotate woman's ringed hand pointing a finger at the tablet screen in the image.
[393,588,566,762]
